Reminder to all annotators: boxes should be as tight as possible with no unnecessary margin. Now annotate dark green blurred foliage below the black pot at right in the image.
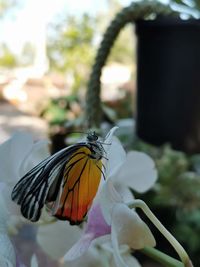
[129,139,200,266]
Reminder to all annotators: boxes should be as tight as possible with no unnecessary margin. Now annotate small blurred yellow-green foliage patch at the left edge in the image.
[0,44,17,68]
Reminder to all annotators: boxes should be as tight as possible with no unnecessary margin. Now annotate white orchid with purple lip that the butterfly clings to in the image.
[61,131,157,267]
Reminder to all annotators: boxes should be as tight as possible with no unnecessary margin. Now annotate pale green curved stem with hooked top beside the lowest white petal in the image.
[128,199,193,267]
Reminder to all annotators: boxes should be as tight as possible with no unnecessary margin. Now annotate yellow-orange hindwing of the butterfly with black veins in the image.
[54,147,103,224]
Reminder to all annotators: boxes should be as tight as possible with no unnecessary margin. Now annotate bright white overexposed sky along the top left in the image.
[0,0,134,54]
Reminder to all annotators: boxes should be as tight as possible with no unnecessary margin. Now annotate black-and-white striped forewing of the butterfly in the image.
[11,143,84,222]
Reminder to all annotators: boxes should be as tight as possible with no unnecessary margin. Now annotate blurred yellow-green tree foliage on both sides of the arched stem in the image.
[47,1,135,92]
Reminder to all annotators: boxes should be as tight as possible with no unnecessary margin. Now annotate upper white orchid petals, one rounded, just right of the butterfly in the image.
[99,139,158,224]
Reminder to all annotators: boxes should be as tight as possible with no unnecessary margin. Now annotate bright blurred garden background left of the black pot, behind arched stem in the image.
[0,0,135,142]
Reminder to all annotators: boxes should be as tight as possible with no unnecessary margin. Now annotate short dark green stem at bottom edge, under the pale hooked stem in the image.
[141,247,184,267]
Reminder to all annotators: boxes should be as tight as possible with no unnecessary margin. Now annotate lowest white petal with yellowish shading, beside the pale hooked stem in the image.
[111,203,155,267]
